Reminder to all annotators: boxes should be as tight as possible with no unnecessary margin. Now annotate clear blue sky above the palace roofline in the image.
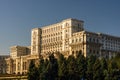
[0,0,120,55]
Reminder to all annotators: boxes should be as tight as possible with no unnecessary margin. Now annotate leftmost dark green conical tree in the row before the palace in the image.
[28,60,39,80]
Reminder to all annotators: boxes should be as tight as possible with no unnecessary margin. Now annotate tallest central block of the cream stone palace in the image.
[31,18,84,55]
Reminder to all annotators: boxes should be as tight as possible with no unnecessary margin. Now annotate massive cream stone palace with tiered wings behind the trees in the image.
[6,18,120,74]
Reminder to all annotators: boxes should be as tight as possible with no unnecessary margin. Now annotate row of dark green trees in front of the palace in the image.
[28,53,120,80]
